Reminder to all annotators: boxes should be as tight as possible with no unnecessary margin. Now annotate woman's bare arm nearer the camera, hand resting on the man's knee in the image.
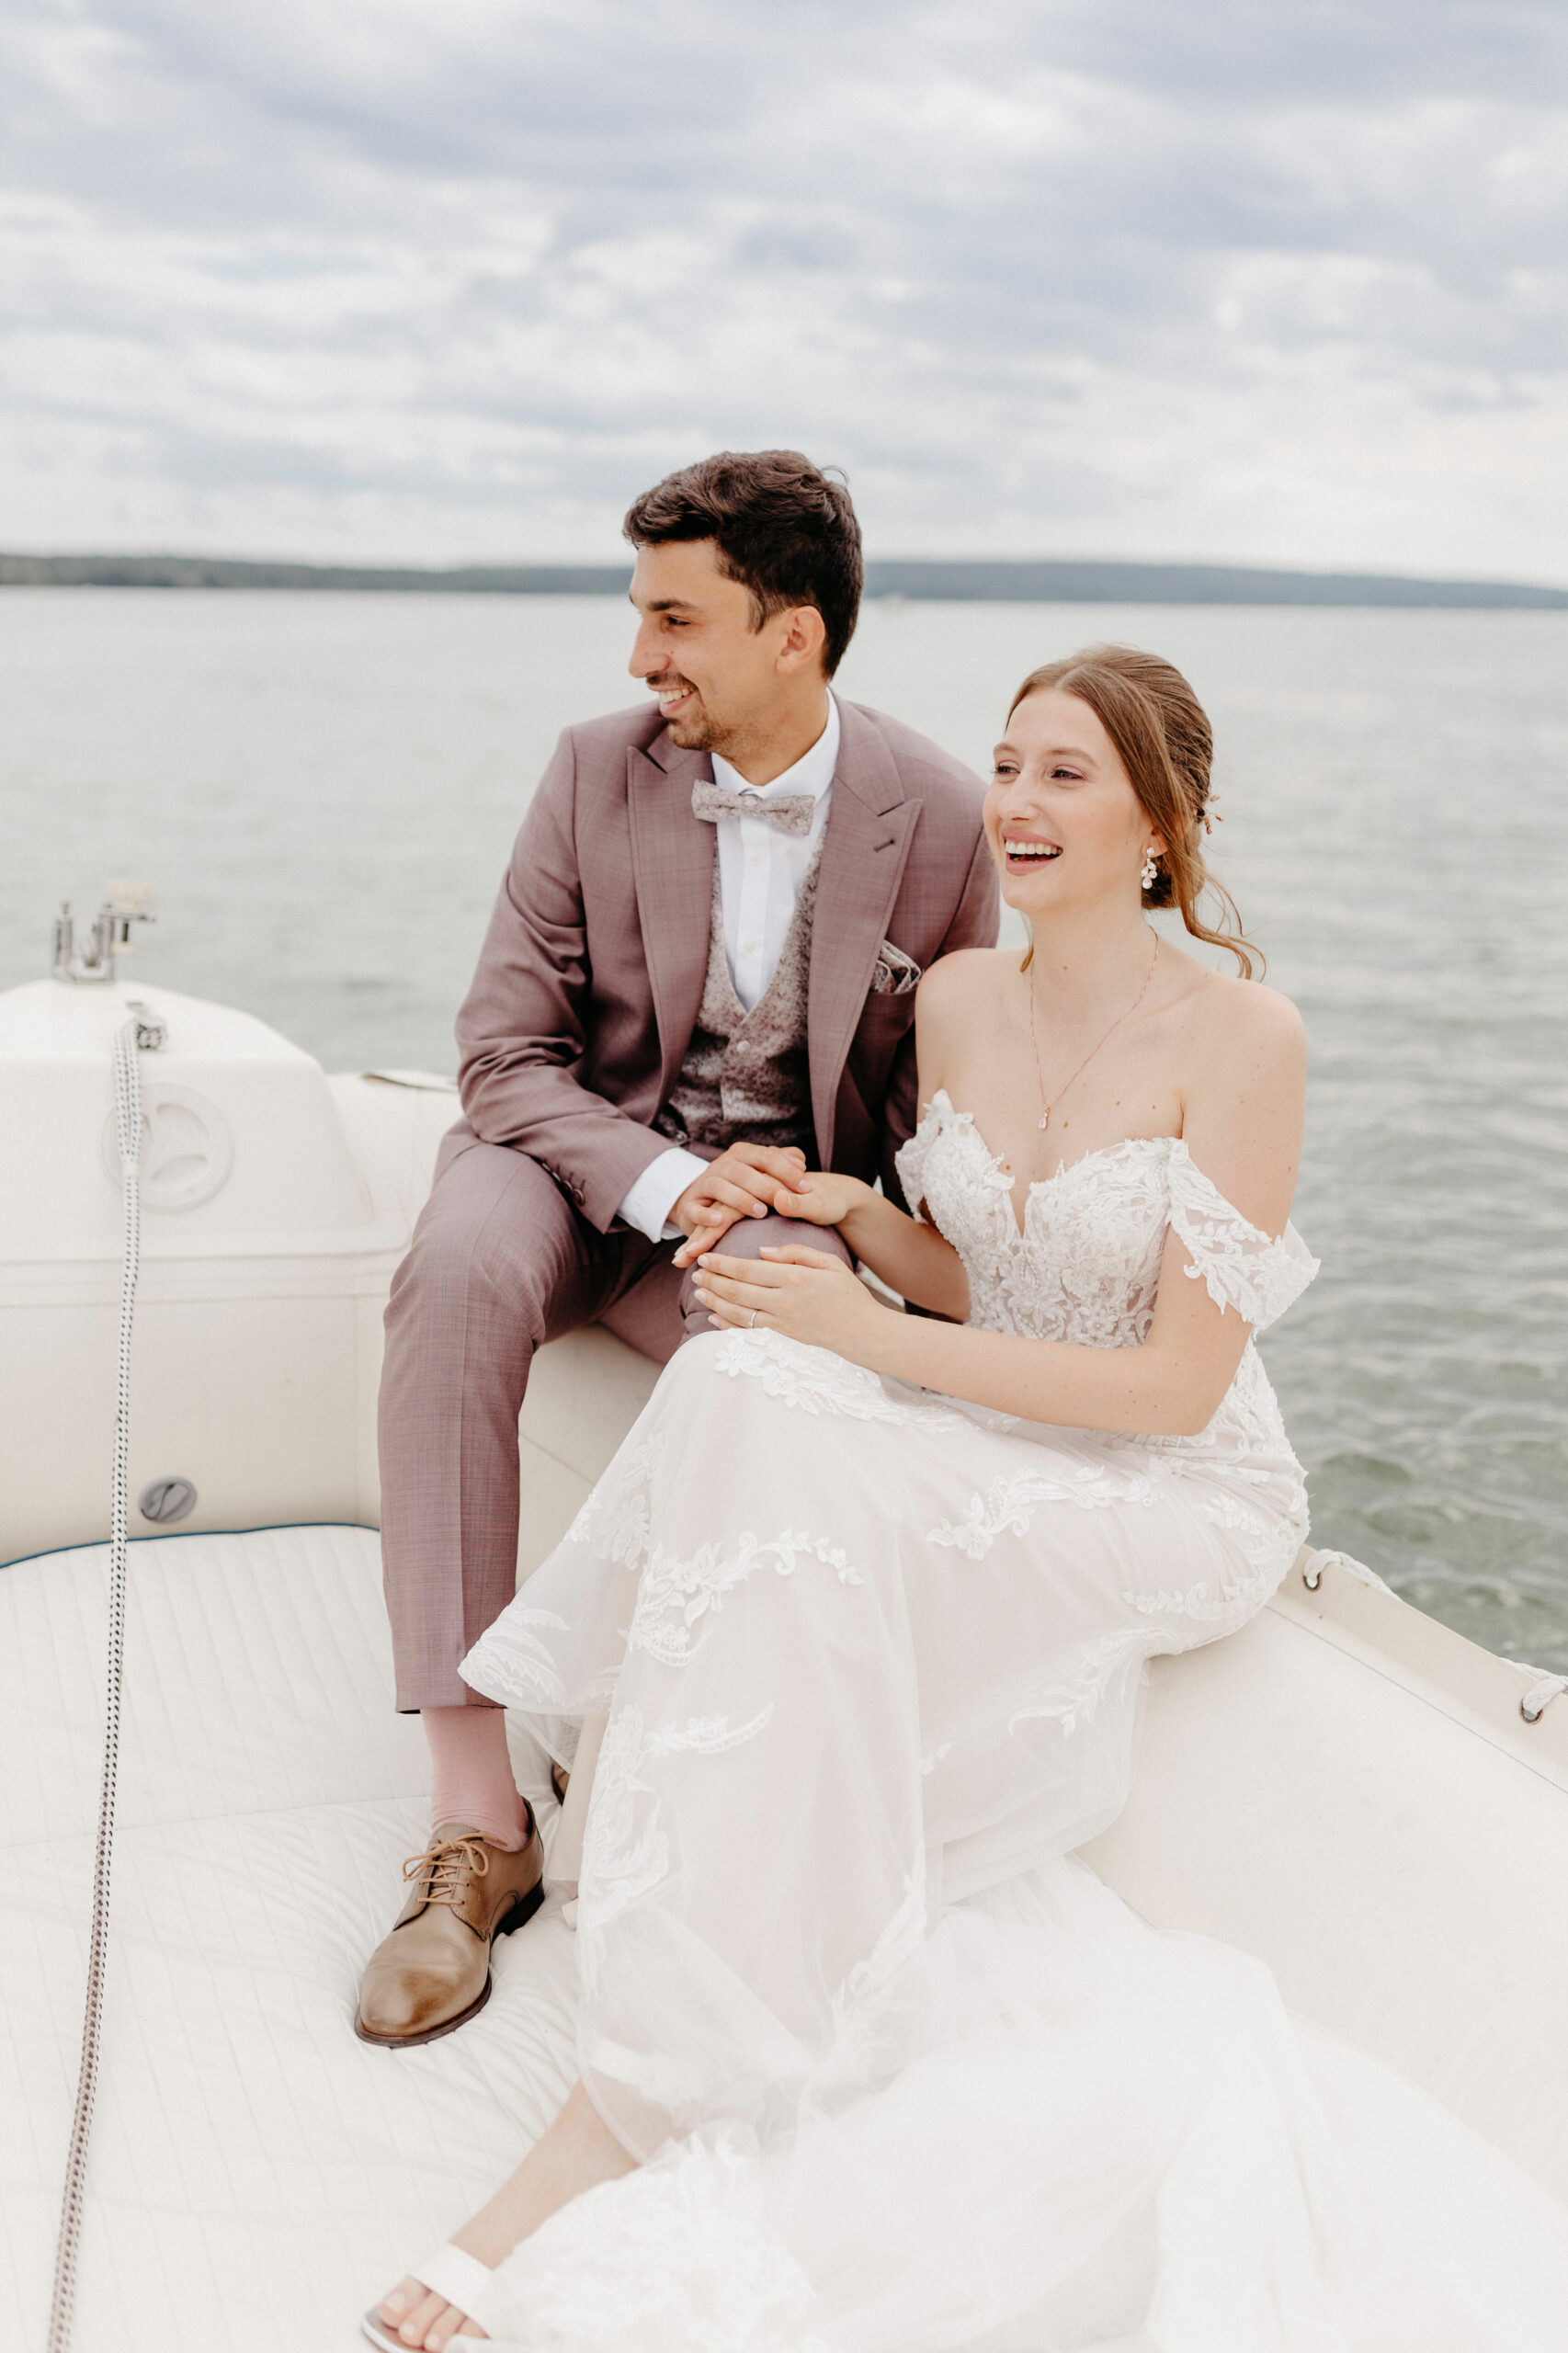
[692,983,1307,1436]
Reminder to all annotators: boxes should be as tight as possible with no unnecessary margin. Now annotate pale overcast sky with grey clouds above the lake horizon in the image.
[0,0,1568,581]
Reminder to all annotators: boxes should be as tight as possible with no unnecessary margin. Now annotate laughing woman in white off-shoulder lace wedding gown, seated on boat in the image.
[365,647,1568,2353]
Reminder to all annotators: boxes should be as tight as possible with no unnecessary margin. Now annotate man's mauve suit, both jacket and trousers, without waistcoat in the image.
[381,697,996,1709]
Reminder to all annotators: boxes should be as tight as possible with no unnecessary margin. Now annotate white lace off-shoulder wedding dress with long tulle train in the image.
[451,1094,1568,2353]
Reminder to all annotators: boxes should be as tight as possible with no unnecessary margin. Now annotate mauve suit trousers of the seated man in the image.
[379,1130,850,1711]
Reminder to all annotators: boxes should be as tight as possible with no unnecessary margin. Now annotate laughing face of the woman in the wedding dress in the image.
[984,688,1165,920]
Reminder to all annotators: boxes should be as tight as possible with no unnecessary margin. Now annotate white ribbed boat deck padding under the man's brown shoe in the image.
[0,1527,574,2353]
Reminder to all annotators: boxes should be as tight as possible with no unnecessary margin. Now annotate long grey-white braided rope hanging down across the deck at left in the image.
[47,1018,153,2353]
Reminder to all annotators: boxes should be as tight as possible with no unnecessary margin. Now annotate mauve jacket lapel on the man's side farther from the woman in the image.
[626,734,716,1101]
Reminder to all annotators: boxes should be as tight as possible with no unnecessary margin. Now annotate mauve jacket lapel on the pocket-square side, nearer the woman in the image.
[805,701,921,1167]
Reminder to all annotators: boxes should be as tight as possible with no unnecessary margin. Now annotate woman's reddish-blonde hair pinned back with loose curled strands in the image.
[1007,644,1265,982]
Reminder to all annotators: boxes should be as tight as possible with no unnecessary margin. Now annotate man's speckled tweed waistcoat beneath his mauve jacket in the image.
[654,847,822,1163]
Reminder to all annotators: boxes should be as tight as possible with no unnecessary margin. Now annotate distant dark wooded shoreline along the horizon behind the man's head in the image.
[0,555,1568,612]
